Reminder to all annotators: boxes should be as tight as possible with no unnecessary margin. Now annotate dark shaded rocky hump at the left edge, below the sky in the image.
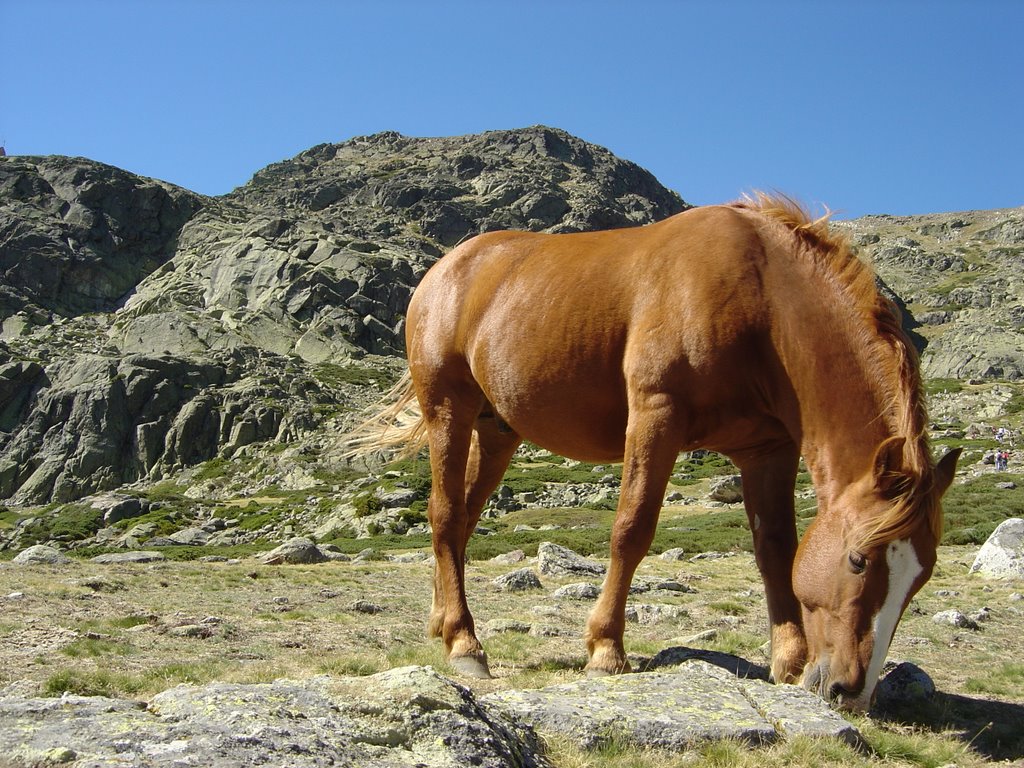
[0,157,204,319]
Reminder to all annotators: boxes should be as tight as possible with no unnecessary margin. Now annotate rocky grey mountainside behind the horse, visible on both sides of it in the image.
[0,127,1024,520]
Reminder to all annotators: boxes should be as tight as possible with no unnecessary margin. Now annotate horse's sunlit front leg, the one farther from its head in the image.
[586,412,679,677]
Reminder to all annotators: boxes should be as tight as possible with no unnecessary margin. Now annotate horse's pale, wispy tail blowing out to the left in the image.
[343,371,427,459]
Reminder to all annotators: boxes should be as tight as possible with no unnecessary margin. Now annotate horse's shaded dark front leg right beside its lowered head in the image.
[740,445,807,683]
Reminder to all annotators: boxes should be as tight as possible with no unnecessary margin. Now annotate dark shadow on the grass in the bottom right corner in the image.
[871,691,1024,761]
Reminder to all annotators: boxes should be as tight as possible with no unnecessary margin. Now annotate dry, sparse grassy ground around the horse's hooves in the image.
[0,536,1024,766]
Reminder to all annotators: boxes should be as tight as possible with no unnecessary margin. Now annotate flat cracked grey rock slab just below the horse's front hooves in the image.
[480,662,859,751]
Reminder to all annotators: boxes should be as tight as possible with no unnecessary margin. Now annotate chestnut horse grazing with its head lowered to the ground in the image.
[353,193,959,711]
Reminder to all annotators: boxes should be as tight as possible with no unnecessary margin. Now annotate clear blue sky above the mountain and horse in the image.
[0,0,1024,216]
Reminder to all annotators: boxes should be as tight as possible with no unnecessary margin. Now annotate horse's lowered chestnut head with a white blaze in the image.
[794,438,959,710]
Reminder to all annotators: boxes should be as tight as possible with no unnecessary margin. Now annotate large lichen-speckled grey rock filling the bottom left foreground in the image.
[0,668,547,768]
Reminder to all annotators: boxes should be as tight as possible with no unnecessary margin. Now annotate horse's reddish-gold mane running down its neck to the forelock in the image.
[734,193,942,549]
